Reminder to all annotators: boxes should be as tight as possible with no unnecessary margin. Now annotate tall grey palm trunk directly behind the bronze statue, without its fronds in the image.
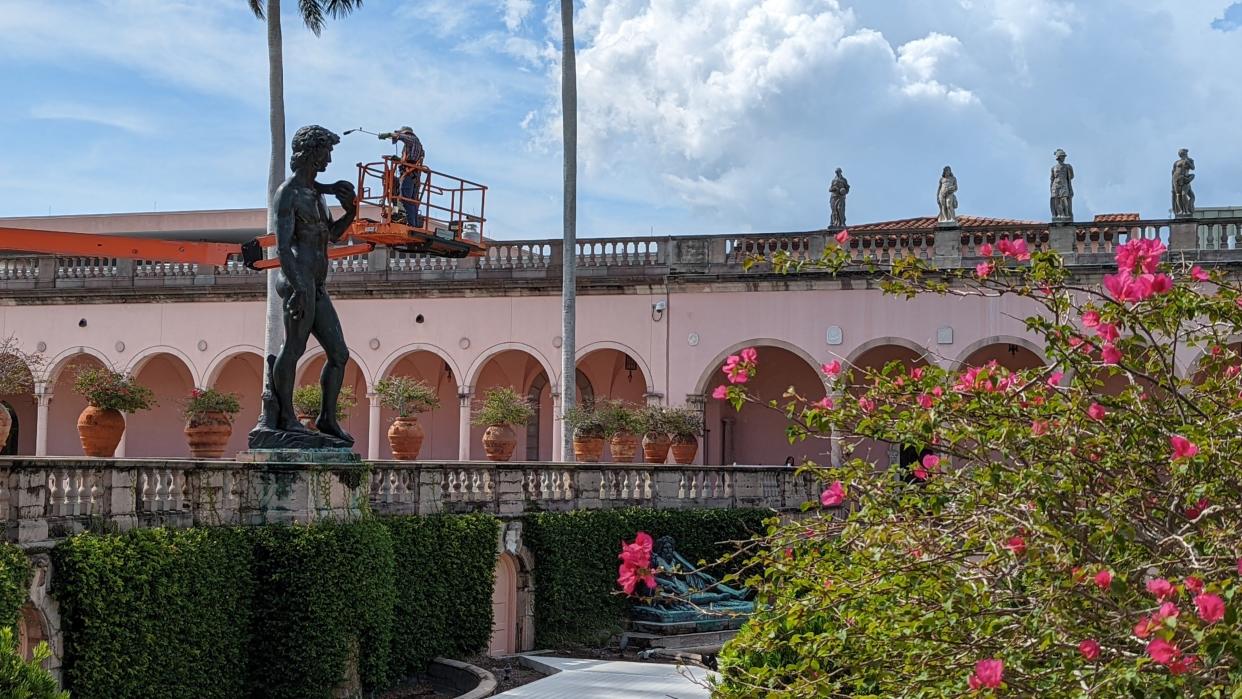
[263,0,284,390]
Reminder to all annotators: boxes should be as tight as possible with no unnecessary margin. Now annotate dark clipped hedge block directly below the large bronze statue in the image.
[247,520,395,699]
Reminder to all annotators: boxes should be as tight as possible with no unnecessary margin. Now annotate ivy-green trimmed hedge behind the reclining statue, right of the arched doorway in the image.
[523,508,771,648]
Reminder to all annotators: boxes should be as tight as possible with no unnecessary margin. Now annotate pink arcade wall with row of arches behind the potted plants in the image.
[0,284,1212,464]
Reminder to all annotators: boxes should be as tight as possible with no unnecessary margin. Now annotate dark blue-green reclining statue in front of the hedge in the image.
[630,536,755,632]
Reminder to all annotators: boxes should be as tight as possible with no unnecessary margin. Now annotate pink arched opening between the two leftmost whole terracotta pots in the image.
[125,353,194,457]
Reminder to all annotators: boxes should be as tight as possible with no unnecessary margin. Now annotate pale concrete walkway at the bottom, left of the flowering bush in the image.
[496,656,712,699]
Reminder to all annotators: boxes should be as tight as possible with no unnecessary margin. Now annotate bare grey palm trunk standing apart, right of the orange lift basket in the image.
[559,0,578,462]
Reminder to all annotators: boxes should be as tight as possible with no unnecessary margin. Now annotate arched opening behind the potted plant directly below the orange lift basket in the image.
[377,350,458,461]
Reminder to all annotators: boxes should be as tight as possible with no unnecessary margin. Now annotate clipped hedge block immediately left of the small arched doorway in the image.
[380,515,501,675]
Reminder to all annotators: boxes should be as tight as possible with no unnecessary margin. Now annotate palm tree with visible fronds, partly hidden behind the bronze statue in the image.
[247,0,363,390]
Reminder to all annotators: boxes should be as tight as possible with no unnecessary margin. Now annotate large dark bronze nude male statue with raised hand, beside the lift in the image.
[250,125,355,449]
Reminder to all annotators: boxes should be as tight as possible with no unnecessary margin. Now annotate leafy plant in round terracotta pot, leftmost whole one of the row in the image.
[73,366,156,458]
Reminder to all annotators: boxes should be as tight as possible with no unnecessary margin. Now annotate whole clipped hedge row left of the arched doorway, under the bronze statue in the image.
[53,515,499,699]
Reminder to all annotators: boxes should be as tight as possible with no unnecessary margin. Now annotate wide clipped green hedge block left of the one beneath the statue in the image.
[52,528,253,699]
